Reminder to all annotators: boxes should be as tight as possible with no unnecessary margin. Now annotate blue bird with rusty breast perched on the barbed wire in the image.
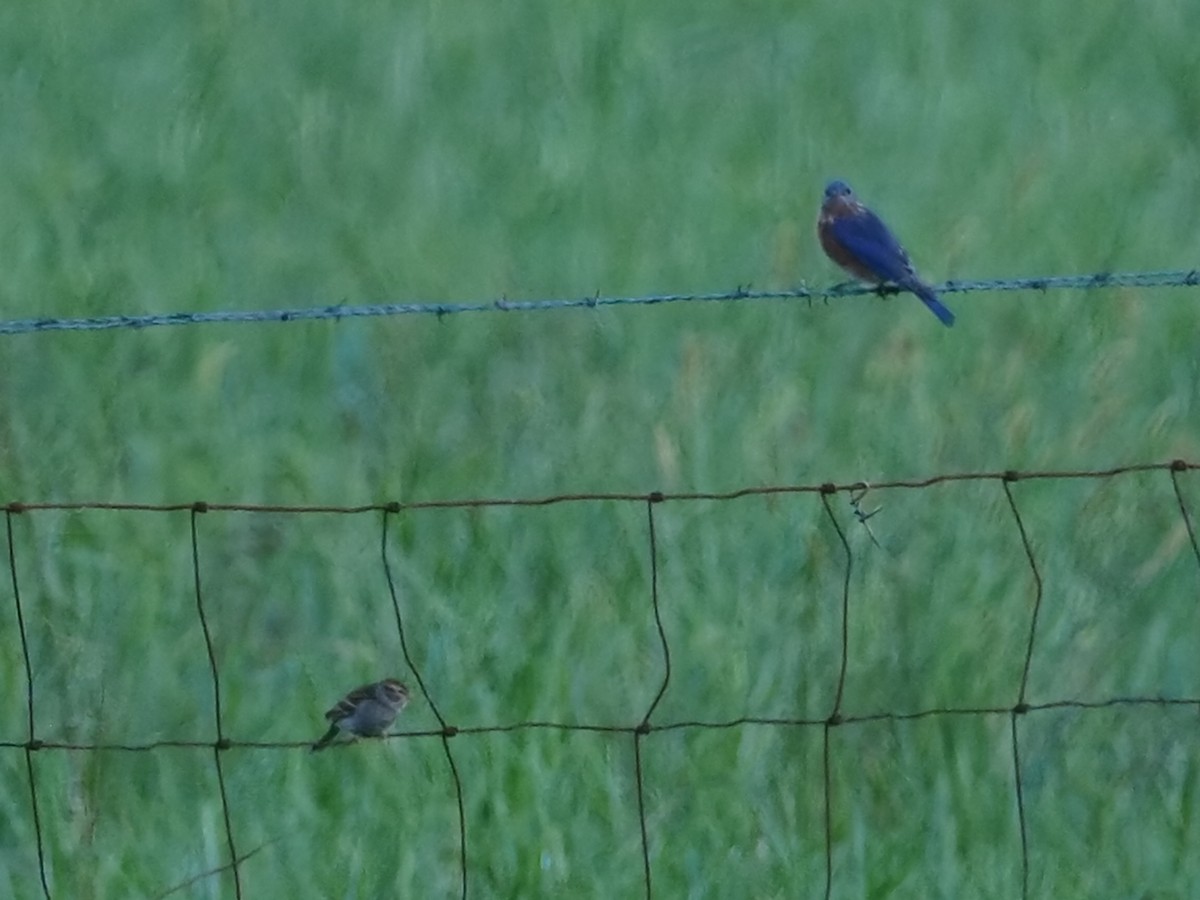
[817,181,954,325]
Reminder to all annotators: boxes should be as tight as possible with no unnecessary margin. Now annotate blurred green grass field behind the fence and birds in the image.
[0,0,1200,898]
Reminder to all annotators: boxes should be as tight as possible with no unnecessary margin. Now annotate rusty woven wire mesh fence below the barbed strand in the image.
[0,460,1200,898]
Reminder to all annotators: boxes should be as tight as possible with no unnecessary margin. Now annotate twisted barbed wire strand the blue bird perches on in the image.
[0,269,1200,335]
